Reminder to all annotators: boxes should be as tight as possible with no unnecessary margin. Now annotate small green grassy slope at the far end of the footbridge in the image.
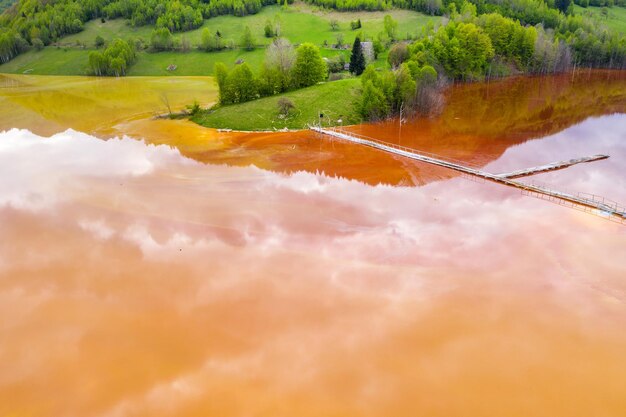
[192,78,361,130]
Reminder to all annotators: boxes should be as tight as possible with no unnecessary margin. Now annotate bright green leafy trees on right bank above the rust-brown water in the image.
[402,2,626,80]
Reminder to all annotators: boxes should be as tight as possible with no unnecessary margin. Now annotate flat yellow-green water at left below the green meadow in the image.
[0,75,215,136]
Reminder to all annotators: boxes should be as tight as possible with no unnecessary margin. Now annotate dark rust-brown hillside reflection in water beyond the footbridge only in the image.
[348,71,626,164]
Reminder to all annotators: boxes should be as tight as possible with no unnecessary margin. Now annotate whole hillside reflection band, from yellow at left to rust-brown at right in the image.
[0,71,626,185]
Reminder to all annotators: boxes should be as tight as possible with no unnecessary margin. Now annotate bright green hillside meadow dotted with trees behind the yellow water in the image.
[0,4,441,76]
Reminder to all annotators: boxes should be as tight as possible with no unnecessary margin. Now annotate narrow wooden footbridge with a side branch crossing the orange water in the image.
[310,127,626,224]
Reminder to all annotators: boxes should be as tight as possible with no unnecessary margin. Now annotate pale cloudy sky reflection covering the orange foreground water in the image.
[0,118,626,416]
